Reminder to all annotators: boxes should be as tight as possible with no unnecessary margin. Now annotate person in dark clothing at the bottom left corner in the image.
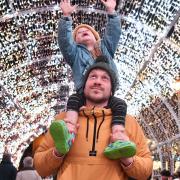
[0,153,17,180]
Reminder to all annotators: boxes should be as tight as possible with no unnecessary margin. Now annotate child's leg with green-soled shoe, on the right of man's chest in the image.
[104,97,136,159]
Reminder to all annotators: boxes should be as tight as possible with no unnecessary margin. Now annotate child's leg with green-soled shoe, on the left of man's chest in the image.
[50,94,83,154]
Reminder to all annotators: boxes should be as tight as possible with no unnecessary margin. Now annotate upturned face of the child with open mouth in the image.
[75,27,96,45]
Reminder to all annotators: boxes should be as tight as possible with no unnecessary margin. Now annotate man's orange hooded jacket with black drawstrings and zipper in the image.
[34,108,152,180]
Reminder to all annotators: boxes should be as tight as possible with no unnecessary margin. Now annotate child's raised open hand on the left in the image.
[60,0,77,16]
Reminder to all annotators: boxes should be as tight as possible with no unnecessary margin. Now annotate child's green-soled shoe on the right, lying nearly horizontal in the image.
[104,141,136,159]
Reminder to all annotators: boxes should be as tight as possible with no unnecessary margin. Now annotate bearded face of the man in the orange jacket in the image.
[84,69,112,107]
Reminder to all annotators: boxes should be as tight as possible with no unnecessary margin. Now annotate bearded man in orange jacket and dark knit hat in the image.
[34,57,152,180]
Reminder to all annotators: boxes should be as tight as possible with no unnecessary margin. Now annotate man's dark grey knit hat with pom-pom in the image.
[82,56,118,95]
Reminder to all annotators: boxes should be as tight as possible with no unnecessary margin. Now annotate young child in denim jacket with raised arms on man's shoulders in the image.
[50,0,136,159]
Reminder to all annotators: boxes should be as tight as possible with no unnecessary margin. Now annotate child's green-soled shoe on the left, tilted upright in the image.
[50,120,72,155]
